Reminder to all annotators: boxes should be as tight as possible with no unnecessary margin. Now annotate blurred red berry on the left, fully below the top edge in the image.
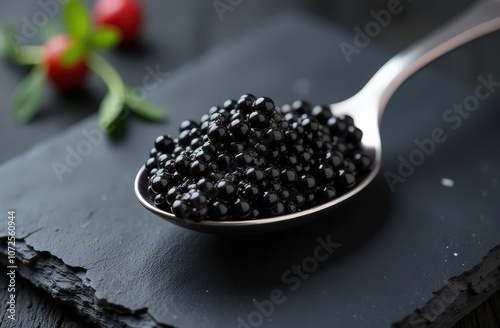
[43,35,89,90]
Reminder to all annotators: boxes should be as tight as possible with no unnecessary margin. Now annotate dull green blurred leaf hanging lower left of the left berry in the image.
[13,66,45,124]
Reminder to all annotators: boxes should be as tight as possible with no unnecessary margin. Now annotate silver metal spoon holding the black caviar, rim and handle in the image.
[134,0,500,234]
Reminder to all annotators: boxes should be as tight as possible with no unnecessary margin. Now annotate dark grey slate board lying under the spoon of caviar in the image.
[0,14,500,327]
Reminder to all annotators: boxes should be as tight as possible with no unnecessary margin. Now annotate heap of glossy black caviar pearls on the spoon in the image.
[145,94,371,221]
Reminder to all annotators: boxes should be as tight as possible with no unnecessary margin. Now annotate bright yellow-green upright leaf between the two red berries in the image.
[63,0,92,42]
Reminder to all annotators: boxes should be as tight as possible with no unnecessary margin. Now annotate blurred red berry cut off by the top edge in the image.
[94,0,144,43]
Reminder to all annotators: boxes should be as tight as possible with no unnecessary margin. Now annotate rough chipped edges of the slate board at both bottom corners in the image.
[0,238,500,328]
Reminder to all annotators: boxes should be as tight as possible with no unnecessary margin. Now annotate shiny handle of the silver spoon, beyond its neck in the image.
[361,0,500,118]
